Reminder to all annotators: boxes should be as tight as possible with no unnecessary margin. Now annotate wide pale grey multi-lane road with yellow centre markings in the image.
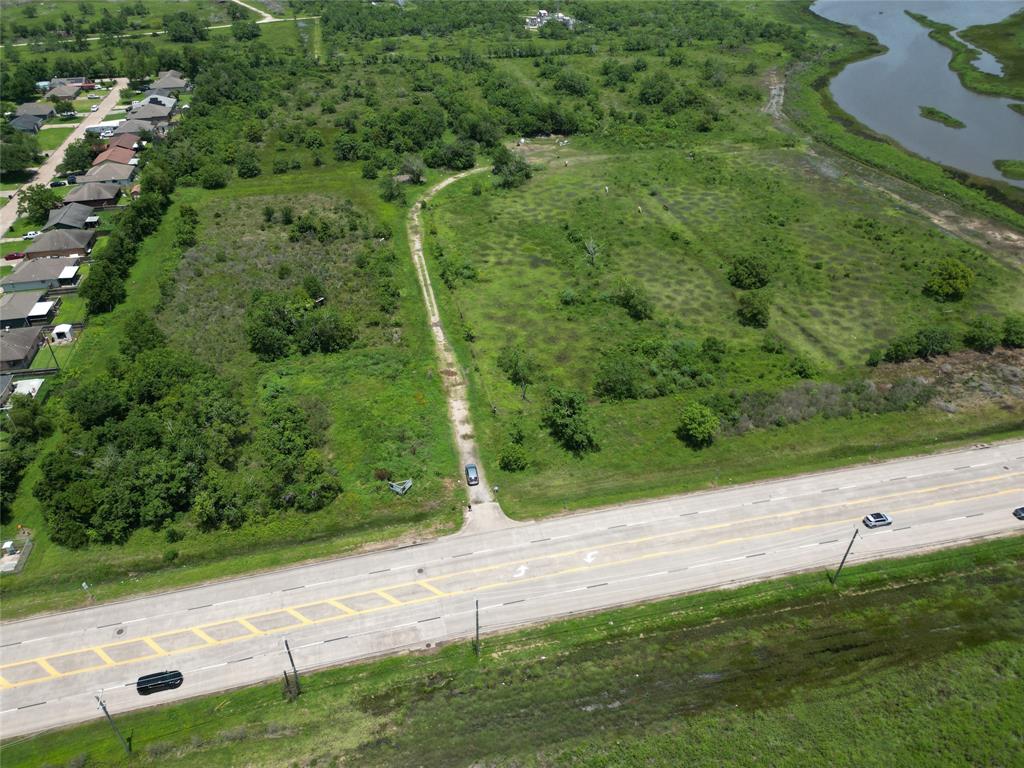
[0,440,1024,738]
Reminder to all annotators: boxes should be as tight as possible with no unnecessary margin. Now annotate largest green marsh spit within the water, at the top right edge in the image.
[905,10,1024,98]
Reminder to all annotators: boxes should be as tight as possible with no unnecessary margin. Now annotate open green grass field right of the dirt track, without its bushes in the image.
[426,146,1024,516]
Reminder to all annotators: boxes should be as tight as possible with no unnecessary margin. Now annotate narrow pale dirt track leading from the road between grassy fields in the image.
[408,168,515,534]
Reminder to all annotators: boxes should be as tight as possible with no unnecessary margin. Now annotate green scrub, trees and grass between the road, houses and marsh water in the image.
[3,2,1021,613]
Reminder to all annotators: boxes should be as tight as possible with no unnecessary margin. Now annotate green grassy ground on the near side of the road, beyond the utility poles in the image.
[0,537,1024,768]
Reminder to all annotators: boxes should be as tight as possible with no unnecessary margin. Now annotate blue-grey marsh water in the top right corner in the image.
[812,0,1024,188]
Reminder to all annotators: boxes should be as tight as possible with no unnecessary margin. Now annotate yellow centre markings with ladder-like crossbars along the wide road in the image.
[0,481,1024,687]
